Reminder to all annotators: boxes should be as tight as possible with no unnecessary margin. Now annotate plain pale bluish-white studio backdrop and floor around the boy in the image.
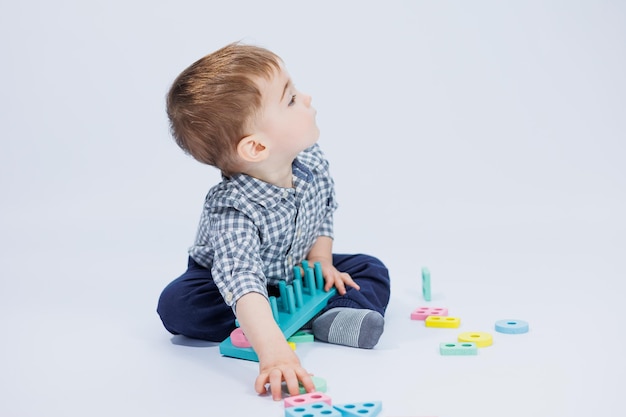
[0,0,626,417]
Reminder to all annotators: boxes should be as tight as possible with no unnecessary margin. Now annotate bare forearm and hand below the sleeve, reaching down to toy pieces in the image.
[237,292,315,401]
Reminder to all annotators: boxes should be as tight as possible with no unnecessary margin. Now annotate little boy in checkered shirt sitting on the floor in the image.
[157,43,389,400]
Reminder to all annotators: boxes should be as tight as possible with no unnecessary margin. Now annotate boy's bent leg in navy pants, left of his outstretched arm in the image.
[157,258,235,342]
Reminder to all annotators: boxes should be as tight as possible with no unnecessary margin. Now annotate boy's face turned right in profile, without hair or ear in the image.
[250,65,320,160]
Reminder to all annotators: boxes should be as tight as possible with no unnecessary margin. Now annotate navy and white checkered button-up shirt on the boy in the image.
[189,144,337,309]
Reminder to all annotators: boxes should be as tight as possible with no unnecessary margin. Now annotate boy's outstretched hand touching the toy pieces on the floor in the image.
[254,343,315,401]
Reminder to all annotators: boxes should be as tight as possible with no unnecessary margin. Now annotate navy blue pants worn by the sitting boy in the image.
[157,254,390,342]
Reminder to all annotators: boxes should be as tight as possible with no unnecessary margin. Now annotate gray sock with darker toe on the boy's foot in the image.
[313,307,385,349]
